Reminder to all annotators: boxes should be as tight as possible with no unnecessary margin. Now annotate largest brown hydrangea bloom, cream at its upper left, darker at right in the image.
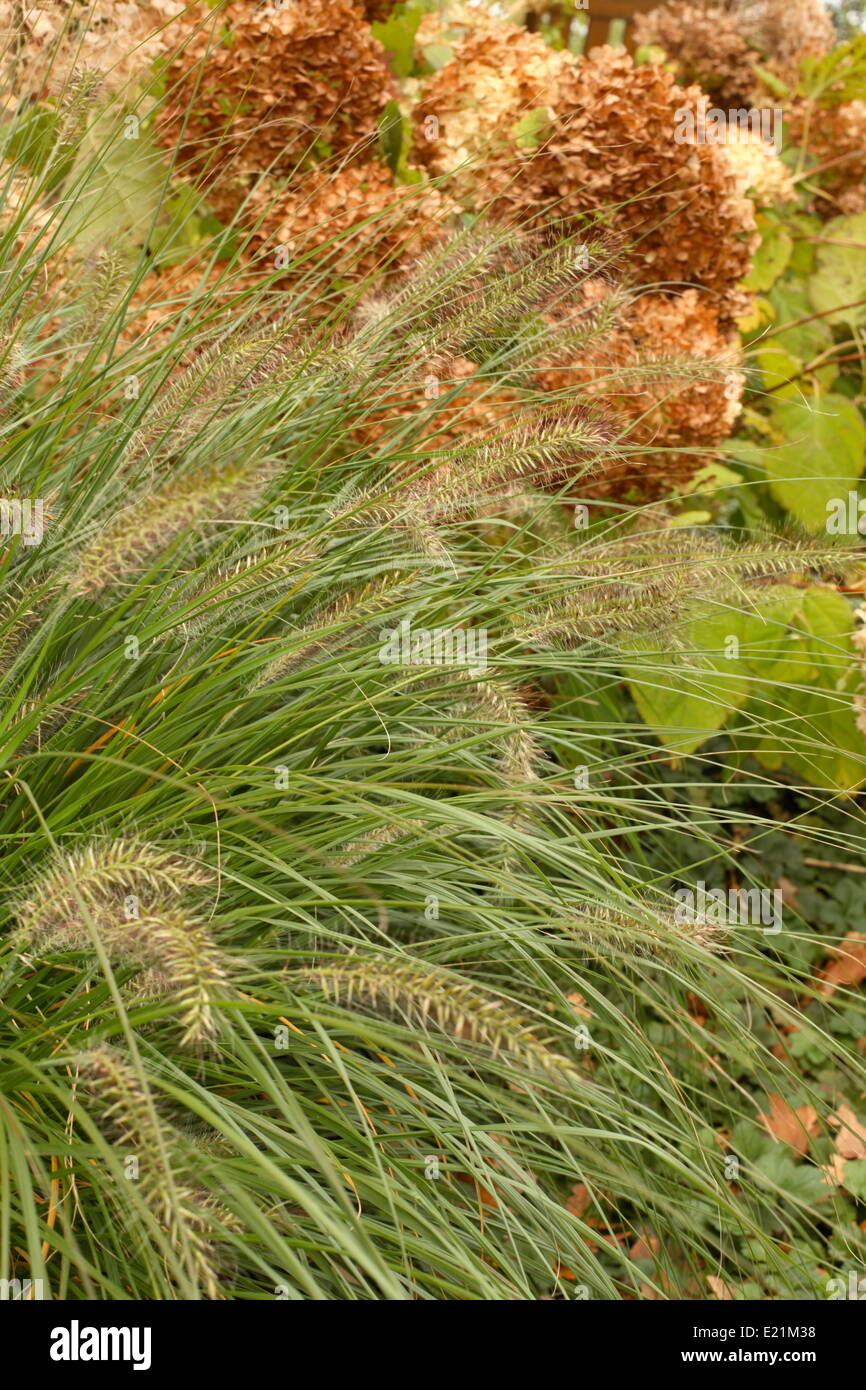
[416,41,756,318]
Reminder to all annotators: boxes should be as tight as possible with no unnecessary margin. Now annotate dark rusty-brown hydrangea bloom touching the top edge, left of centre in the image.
[160,0,395,195]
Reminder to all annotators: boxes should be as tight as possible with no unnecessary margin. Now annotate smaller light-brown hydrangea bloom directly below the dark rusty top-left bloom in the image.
[245,161,449,287]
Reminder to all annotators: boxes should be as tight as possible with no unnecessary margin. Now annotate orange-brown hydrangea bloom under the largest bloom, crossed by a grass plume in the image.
[537,284,744,499]
